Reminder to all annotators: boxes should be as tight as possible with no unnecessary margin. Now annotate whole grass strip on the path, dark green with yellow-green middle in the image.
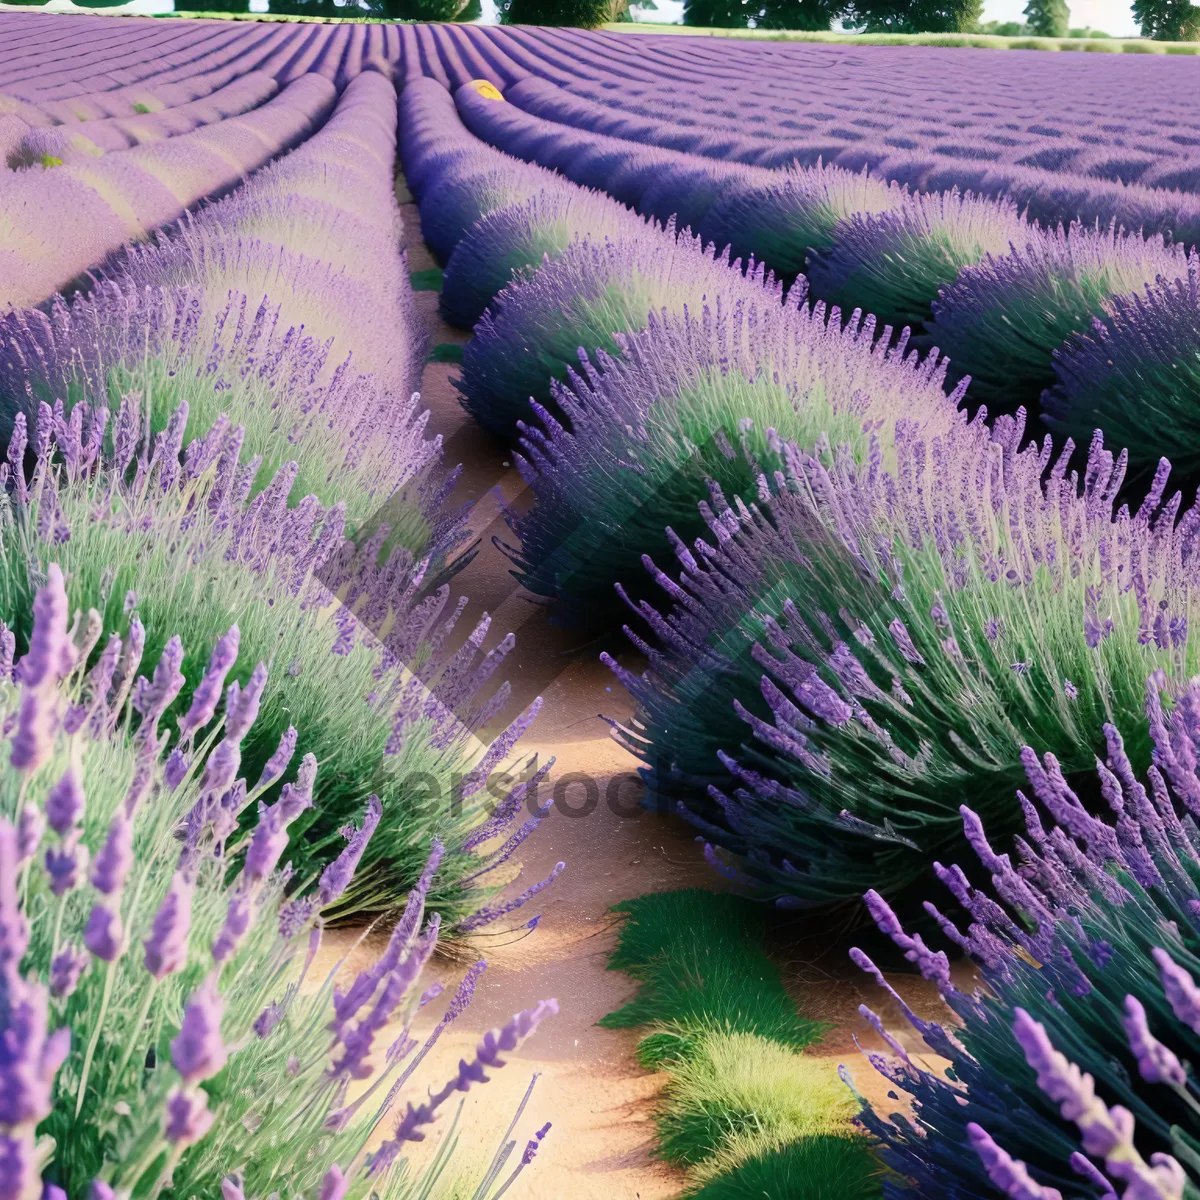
[600,888,881,1200]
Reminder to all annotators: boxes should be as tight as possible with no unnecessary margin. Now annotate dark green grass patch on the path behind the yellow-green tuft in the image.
[600,888,824,1064]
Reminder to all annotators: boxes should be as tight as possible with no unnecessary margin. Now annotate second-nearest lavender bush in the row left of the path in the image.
[0,396,544,920]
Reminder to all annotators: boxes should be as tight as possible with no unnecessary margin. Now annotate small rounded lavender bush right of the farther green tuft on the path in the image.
[440,185,643,329]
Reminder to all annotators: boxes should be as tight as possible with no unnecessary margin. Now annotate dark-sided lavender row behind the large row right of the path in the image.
[451,80,1200,482]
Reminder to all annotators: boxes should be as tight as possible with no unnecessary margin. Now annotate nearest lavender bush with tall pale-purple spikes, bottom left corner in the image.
[0,565,556,1200]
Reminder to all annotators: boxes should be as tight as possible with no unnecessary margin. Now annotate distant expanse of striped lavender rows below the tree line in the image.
[9,13,1200,243]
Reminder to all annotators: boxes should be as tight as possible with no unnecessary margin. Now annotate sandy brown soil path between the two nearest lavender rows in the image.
[376,181,964,1200]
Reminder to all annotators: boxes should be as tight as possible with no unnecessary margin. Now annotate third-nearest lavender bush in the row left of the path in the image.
[0,282,440,550]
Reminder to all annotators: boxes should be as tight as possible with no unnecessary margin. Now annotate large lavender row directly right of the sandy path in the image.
[402,68,1200,1200]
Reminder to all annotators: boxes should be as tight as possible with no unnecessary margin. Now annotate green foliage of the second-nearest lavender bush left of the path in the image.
[0,404,535,925]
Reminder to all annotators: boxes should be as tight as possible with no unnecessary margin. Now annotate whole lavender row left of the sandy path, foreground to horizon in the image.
[0,60,557,1200]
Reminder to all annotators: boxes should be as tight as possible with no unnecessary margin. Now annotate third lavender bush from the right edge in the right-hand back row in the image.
[811,188,1037,344]
